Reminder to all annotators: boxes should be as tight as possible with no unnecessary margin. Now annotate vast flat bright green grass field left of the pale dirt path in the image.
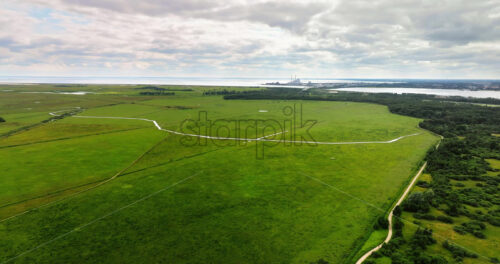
[0,85,438,263]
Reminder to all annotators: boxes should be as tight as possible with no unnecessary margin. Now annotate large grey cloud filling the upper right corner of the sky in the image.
[321,0,500,45]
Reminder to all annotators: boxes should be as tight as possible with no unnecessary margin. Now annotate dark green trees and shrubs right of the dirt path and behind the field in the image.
[226,90,500,263]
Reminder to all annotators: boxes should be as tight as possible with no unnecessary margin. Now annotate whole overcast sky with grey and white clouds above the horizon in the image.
[0,0,500,79]
